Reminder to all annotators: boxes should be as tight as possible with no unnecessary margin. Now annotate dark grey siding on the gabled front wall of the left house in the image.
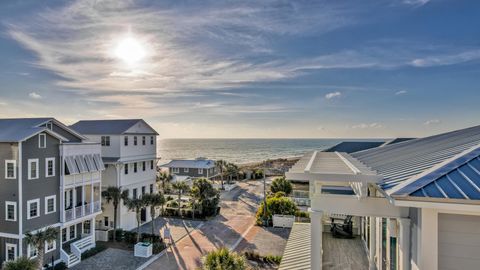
[22,134,60,232]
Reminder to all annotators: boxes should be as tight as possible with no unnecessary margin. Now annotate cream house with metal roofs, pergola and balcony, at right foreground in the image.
[280,126,480,270]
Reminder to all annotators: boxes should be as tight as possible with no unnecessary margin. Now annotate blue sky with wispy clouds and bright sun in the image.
[0,0,480,138]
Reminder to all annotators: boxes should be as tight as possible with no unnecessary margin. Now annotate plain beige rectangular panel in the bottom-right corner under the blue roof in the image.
[438,214,480,270]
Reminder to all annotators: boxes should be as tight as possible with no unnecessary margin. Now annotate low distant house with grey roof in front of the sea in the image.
[160,158,218,179]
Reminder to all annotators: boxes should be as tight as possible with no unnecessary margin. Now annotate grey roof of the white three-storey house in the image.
[70,119,158,135]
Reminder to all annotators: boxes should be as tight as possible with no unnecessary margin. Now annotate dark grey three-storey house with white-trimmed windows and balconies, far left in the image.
[0,118,103,266]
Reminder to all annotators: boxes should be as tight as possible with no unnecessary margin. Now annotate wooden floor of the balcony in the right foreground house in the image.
[323,232,368,270]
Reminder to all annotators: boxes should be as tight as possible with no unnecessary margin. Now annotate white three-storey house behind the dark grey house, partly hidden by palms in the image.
[71,119,158,230]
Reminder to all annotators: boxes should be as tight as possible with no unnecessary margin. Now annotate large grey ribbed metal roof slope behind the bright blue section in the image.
[350,126,480,193]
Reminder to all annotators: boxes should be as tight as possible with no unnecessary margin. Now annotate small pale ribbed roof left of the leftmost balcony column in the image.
[278,223,311,270]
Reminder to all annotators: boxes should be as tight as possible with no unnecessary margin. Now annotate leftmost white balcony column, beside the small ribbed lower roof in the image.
[310,209,323,270]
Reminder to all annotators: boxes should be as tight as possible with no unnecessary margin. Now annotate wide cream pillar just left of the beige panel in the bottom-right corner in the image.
[420,208,438,270]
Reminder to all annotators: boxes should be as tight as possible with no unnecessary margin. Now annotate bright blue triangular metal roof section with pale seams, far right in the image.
[392,146,480,200]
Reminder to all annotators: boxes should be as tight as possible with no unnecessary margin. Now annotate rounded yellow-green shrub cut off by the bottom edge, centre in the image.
[202,248,247,270]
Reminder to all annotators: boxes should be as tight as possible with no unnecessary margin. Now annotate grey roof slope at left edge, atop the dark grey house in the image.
[0,118,53,142]
